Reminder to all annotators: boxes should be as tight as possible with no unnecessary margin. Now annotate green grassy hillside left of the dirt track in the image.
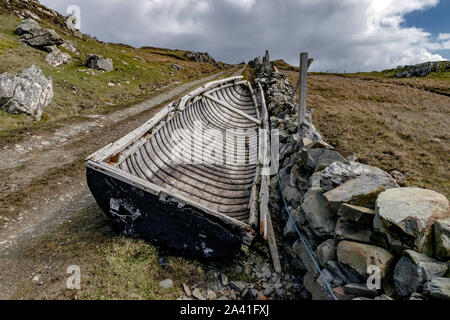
[0,0,226,141]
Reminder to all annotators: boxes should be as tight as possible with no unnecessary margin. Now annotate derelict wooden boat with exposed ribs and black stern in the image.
[86,77,268,260]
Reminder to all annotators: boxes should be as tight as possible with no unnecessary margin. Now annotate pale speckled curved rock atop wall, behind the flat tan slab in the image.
[321,161,394,191]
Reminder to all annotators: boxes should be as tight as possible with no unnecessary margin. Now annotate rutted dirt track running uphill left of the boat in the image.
[0,70,242,299]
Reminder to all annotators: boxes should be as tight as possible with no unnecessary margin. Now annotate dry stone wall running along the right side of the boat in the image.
[252,53,450,300]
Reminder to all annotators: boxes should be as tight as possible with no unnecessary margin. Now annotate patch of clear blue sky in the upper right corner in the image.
[404,0,450,60]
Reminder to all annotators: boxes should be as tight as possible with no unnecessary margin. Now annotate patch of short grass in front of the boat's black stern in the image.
[14,205,209,300]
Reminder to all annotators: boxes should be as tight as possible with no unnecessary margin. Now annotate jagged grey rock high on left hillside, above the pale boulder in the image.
[16,19,64,48]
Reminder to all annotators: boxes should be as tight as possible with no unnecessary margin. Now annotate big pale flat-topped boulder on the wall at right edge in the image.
[374,188,450,256]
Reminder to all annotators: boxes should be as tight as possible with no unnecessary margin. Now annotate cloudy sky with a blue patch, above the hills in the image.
[41,0,450,72]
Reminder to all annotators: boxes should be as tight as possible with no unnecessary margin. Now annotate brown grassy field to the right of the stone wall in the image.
[285,71,450,197]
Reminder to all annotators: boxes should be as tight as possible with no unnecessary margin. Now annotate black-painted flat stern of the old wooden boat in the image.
[86,168,246,261]
